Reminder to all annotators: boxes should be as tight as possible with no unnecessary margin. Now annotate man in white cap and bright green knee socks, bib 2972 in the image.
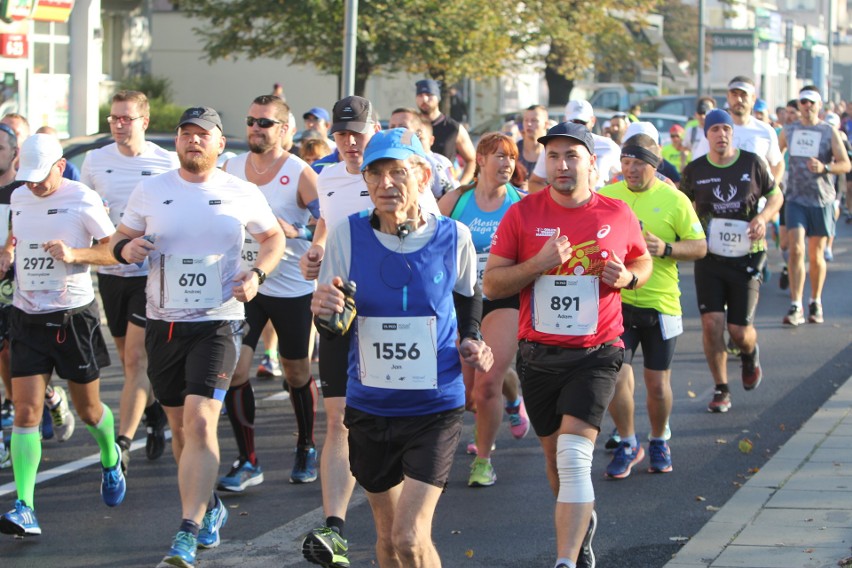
[0,134,126,536]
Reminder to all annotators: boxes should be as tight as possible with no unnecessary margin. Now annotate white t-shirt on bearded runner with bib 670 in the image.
[121,169,278,321]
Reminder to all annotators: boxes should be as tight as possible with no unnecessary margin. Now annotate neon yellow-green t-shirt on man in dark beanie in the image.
[600,180,706,316]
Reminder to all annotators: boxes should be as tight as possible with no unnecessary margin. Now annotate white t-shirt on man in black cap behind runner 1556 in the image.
[317,162,373,229]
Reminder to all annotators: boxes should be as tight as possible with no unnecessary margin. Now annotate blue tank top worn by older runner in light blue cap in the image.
[346,212,465,416]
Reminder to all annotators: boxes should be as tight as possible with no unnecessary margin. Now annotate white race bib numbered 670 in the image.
[160,254,222,309]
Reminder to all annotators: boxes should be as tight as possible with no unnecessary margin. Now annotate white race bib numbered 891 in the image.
[533,275,600,335]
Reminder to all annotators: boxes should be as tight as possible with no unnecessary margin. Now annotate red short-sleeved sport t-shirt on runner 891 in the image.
[491,188,647,348]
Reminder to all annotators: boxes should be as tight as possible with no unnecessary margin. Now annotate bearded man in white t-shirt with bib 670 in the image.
[110,107,285,567]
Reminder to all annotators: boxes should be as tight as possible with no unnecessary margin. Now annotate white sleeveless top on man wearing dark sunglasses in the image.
[227,152,316,298]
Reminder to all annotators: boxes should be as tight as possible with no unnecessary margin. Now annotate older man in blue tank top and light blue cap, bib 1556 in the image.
[311,128,493,568]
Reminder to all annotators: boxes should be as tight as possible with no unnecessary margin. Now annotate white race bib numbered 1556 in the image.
[358,316,438,390]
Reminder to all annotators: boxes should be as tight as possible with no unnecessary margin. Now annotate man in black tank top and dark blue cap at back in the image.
[415,79,476,185]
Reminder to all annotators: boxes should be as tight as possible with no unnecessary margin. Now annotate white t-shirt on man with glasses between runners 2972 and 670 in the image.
[80,142,180,276]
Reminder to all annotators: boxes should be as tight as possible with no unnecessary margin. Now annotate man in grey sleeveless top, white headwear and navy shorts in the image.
[781,86,852,326]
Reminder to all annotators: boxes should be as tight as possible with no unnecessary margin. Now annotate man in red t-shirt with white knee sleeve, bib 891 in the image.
[483,122,652,568]
